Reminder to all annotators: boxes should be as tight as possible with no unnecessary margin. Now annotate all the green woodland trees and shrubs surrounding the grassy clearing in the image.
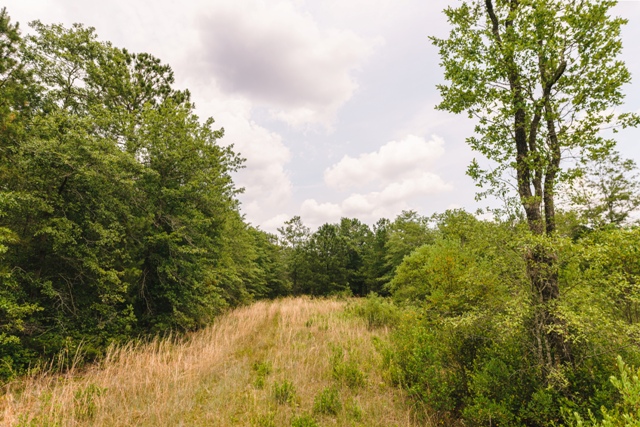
[0,0,640,426]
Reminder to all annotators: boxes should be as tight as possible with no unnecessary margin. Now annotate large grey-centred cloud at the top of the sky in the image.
[199,0,376,126]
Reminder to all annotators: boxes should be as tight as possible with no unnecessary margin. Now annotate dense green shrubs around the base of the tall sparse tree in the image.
[385,213,640,426]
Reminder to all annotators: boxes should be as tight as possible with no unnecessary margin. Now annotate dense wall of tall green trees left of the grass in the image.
[0,11,289,380]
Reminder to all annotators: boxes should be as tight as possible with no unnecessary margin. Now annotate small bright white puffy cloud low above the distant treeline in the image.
[324,135,444,190]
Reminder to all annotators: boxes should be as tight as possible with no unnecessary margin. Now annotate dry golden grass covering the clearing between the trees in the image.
[0,298,428,427]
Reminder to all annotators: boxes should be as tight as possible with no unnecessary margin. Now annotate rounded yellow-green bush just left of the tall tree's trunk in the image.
[388,212,526,317]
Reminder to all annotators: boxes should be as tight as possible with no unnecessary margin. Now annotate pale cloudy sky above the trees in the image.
[4,0,640,232]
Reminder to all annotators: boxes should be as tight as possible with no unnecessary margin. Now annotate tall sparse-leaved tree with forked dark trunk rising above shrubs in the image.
[432,0,638,378]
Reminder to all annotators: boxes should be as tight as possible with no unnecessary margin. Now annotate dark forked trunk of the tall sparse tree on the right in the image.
[485,0,571,379]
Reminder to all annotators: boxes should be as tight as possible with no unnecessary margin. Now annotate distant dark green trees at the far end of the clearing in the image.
[278,211,432,296]
